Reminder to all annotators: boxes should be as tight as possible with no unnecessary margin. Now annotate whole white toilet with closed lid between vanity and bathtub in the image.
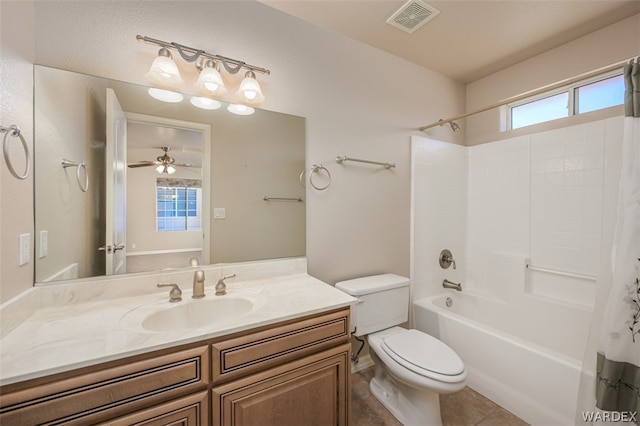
[336,274,467,426]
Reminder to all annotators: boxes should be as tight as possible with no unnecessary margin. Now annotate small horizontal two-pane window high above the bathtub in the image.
[507,71,624,129]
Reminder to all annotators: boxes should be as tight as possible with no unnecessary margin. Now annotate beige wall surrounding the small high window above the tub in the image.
[466,14,640,145]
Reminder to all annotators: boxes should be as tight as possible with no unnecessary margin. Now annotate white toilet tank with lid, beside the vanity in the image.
[336,274,410,336]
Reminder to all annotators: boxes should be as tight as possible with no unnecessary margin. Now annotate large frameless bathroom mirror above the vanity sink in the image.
[34,65,305,284]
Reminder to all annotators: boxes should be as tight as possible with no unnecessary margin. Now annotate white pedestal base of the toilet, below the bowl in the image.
[369,365,442,426]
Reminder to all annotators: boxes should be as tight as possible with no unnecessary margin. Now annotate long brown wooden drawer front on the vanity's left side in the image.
[0,346,210,425]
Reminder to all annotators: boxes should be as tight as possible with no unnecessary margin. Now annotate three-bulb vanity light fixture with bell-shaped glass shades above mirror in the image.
[136,35,271,104]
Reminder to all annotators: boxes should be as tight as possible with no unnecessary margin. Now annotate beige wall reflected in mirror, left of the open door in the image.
[34,69,107,282]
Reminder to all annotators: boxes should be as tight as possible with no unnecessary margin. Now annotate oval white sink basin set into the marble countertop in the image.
[121,291,266,332]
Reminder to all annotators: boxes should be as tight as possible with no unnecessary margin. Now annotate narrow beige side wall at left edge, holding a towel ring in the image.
[0,1,35,302]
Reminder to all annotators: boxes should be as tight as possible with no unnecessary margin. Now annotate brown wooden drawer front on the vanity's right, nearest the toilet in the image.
[211,308,349,383]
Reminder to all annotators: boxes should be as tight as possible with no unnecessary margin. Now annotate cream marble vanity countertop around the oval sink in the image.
[0,258,355,385]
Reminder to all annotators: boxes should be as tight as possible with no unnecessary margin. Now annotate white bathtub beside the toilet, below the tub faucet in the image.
[413,291,591,426]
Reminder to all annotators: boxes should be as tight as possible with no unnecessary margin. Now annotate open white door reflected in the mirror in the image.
[105,89,127,275]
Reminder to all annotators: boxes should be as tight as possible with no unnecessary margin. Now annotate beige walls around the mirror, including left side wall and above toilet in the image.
[0,1,464,300]
